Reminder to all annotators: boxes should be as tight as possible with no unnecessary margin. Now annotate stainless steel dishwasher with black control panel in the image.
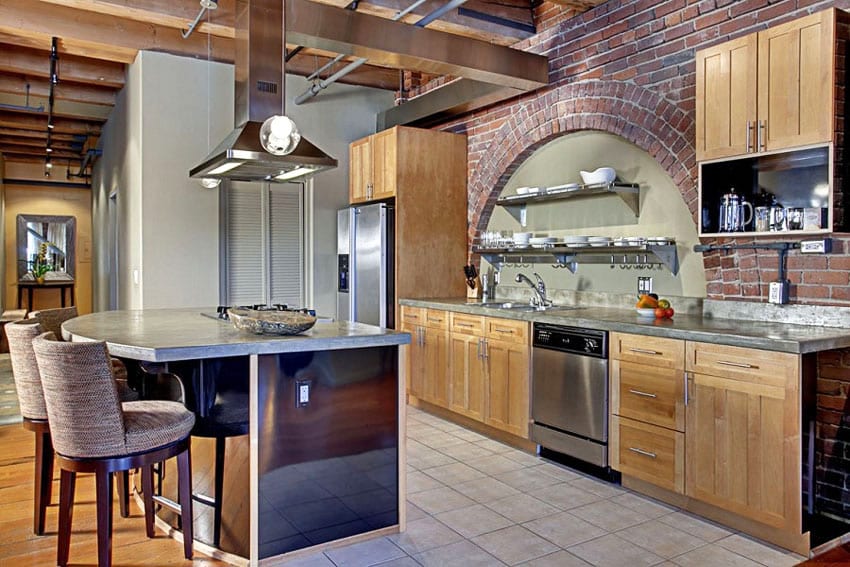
[531,323,608,467]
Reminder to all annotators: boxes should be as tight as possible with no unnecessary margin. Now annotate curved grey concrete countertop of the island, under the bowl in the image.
[62,307,410,362]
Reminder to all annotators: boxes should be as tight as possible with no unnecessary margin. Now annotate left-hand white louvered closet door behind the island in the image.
[224,181,266,305]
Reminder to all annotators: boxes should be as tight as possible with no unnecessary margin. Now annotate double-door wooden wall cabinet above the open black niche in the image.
[696,9,838,161]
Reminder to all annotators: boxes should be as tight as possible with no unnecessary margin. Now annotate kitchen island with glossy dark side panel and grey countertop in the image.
[62,309,410,565]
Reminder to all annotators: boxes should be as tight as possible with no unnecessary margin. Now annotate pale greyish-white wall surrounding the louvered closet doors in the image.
[92,52,393,315]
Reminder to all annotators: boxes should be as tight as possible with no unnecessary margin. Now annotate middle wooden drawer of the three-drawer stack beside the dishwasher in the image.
[611,360,685,431]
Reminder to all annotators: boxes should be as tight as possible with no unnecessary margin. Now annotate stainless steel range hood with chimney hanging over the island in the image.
[189,0,337,183]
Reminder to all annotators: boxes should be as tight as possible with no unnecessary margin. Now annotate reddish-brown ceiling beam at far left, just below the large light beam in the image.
[0,42,124,89]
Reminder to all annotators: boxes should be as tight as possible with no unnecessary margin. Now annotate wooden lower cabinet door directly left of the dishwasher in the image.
[484,339,529,439]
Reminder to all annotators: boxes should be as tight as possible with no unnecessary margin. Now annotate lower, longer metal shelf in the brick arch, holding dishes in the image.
[472,243,679,275]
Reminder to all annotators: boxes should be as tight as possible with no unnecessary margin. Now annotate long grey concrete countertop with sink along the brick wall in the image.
[399,299,850,354]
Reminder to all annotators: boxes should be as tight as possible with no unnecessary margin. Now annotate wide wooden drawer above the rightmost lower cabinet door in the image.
[686,341,800,388]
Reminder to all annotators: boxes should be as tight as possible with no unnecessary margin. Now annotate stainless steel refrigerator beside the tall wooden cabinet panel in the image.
[336,203,395,328]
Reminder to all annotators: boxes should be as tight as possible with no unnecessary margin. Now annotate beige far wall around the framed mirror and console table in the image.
[3,182,92,313]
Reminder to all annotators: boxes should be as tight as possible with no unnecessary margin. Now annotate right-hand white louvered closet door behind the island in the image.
[269,183,305,307]
